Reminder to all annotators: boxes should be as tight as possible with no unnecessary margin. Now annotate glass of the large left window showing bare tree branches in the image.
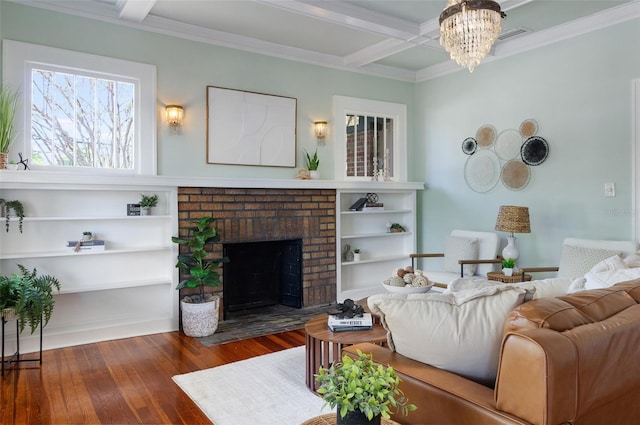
[31,69,135,169]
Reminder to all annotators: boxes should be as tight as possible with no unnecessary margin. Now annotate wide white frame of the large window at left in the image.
[2,40,157,175]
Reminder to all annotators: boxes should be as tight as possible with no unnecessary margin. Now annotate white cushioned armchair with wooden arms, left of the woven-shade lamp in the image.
[409,229,502,288]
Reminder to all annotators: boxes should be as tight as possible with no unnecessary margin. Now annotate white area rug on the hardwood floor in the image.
[173,347,324,425]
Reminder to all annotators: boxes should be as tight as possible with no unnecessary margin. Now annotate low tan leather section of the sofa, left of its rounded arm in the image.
[343,343,528,425]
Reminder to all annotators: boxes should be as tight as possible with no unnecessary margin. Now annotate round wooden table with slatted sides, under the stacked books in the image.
[304,314,387,392]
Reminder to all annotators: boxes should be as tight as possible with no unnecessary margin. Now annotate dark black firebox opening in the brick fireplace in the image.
[222,239,302,318]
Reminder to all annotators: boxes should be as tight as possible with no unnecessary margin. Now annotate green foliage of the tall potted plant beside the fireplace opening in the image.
[171,217,229,302]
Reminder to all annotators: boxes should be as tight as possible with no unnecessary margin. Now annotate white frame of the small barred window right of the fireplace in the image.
[333,95,407,182]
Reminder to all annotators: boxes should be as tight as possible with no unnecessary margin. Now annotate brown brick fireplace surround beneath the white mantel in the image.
[178,187,336,314]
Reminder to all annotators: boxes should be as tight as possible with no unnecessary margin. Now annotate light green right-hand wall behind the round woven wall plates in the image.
[415,19,640,265]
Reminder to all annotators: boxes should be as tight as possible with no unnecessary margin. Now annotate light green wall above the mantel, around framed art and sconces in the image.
[1,2,413,179]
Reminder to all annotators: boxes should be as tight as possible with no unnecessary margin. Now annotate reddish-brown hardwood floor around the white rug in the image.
[0,329,305,425]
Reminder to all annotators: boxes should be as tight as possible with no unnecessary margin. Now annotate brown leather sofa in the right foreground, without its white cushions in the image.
[344,279,640,425]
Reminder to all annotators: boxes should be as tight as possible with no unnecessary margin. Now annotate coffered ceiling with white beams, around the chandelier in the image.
[11,0,640,81]
